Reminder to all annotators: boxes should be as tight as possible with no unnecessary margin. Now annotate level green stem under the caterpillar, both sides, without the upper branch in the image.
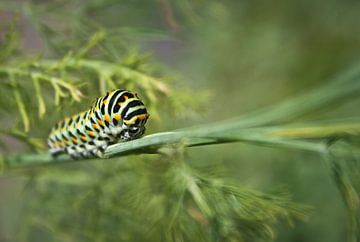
[3,123,360,168]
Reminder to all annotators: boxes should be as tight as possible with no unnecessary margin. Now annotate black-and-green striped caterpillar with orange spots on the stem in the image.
[47,89,149,159]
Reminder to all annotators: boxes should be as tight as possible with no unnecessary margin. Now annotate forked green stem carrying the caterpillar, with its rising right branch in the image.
[3,62,360,168]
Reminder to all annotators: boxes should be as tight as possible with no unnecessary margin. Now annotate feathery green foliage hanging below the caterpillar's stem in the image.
[14,151,309,241]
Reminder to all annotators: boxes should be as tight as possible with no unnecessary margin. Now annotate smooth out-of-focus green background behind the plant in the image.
[0,0,360,242]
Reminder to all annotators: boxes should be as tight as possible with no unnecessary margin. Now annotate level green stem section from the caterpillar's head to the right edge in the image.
[105,123,360,157]
